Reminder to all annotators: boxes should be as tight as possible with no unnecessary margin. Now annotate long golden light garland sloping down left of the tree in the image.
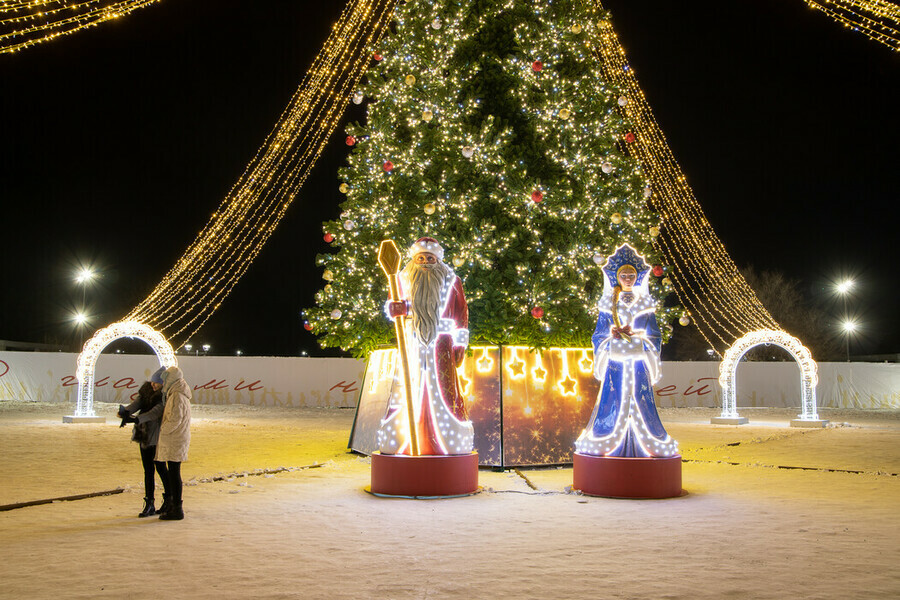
[125,0,396,348]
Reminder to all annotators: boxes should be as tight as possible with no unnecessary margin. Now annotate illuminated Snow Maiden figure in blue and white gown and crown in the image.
[575,244,678,457]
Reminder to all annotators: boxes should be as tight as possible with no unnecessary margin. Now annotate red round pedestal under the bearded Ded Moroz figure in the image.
[369,452,478,497]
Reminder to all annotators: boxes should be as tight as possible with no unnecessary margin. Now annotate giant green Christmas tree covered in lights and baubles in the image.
[305,0,681,355]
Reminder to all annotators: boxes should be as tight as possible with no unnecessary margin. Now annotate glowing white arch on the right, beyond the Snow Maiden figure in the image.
[719,329,819,422]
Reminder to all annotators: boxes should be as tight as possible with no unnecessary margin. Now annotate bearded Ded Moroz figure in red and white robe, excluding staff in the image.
[378,237,475,456]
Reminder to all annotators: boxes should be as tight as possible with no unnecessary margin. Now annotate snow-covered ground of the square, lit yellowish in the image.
[0,402,900,600]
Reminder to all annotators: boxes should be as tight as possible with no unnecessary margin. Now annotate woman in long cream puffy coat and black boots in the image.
[156,367,191,521]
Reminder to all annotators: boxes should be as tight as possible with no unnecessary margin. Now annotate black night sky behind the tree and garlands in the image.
[0,0,900,355]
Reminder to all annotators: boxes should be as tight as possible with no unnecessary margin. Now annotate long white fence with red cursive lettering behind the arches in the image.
[0,352,900,409]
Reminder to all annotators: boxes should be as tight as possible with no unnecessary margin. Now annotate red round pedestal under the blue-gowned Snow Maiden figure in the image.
[572,452,682,498]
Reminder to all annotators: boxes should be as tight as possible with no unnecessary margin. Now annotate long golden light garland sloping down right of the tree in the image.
[595,0,780,350]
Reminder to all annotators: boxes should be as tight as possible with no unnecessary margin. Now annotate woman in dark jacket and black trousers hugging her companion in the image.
[119,368,170,517]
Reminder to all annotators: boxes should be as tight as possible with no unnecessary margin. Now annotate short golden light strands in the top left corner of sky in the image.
[0,0,160,54]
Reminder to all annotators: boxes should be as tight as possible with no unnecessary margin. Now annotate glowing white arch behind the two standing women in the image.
[75,321,178,418]
